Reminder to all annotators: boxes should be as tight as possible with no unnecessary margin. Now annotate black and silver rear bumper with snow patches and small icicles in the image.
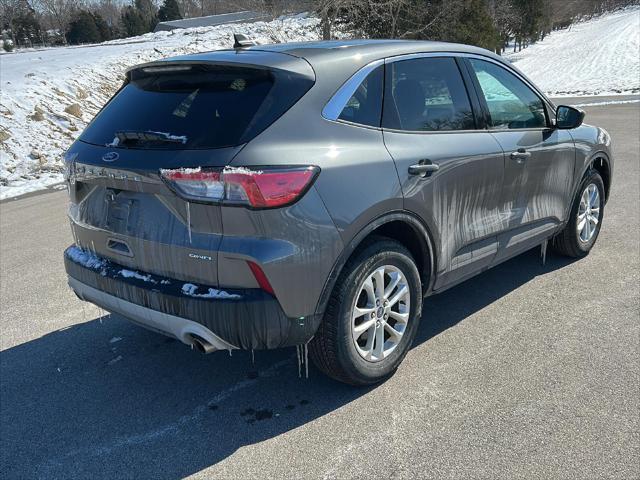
[64,246,319,349]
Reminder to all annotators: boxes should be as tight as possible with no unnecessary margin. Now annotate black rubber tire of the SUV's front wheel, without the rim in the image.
[551,170,605,258]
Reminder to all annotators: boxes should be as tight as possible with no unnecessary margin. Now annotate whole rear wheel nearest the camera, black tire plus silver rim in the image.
[309,237,422,385]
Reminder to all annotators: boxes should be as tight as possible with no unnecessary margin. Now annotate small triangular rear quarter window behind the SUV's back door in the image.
[338,66,384,127]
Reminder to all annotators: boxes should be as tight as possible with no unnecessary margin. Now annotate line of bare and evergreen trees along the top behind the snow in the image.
[0,0,640,53]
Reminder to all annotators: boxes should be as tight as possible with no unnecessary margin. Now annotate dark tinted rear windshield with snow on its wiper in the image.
[80,65,313,149]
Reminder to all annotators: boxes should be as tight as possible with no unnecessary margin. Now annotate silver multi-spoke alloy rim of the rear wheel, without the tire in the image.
[351,265,411,362]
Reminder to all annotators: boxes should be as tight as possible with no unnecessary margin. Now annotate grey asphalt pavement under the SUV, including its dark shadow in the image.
[0,99,640,479]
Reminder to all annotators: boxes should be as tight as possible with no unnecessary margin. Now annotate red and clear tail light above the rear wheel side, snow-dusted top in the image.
[160,166,320,208]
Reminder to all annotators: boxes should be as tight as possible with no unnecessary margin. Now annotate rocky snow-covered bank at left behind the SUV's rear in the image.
[0,16,318,199]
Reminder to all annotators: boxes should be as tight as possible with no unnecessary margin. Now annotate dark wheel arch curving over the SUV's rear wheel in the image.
[316,210,437,314]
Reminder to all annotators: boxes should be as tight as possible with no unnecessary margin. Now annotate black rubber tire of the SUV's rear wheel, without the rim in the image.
[309,237,422,385]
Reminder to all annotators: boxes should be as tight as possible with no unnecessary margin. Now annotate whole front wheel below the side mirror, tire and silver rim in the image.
[552,170,605,258]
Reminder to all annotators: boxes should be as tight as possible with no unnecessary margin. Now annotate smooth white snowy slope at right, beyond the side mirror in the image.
[506,6,640,96]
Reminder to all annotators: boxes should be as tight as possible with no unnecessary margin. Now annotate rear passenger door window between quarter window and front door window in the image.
[383,57,475,132]
